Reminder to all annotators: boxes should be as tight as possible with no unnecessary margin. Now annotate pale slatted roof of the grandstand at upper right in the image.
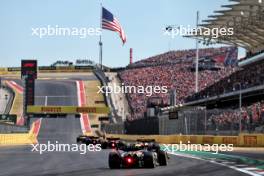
[191,0,264,52]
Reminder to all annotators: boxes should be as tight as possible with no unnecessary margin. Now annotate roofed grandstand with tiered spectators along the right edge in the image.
[182,0,264,131]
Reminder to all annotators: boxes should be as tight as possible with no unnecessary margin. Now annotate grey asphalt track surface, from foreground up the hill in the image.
[0,80,250,176]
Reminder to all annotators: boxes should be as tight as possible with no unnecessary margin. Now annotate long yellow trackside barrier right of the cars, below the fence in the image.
[107,133,264,147]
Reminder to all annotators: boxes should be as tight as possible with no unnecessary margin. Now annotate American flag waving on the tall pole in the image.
[102,7,126,44]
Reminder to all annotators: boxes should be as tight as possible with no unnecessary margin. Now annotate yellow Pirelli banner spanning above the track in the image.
[27,106,109,114]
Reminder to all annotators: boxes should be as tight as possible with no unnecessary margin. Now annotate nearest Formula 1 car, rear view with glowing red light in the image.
[108,140,168,169]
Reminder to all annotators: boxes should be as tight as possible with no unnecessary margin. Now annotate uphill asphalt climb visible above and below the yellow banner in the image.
[35,81,81,144]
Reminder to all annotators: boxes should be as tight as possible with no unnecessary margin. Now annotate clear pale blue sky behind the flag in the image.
[0,0,243,67]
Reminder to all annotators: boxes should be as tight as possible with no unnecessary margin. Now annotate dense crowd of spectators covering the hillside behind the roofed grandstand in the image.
[119,47,237,119]
